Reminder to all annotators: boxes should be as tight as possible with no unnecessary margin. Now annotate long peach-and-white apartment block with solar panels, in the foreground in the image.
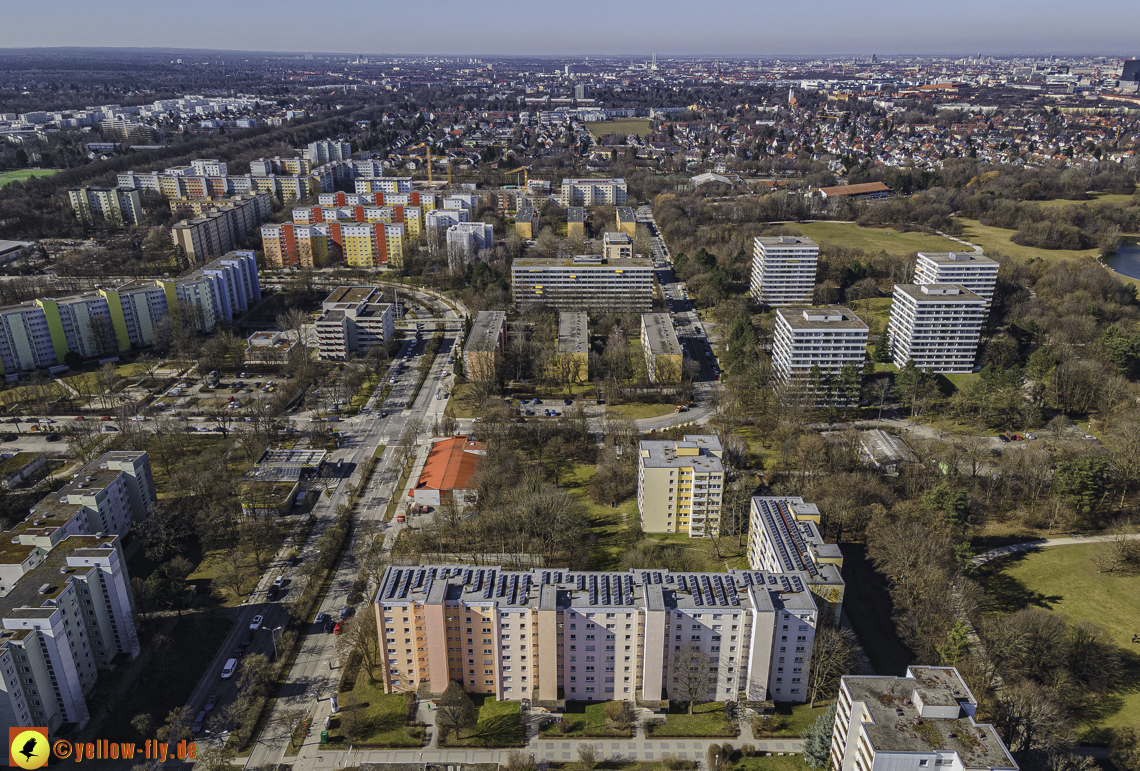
[374,566,819,703]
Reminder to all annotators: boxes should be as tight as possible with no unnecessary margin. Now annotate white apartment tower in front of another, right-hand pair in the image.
[887,284,986,373]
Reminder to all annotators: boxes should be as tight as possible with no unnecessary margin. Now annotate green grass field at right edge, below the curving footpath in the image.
[980,545,1140,740]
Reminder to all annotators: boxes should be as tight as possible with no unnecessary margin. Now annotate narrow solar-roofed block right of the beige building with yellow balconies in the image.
[748,496,845,626]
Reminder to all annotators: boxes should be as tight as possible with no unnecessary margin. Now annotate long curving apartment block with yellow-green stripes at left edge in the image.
[0,252,261,373]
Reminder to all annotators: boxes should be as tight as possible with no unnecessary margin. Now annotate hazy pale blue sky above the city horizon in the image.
[0,0,1140,57]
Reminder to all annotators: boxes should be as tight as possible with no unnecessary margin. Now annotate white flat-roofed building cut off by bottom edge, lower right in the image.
[830,666,1018,771]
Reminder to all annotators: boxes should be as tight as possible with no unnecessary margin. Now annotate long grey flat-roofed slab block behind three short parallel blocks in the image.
[511,254,653,314]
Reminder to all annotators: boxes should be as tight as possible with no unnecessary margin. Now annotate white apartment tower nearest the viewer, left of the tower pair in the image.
[772,306,868,406]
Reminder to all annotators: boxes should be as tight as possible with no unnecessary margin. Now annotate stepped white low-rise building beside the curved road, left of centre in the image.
[314,286,396,362]
